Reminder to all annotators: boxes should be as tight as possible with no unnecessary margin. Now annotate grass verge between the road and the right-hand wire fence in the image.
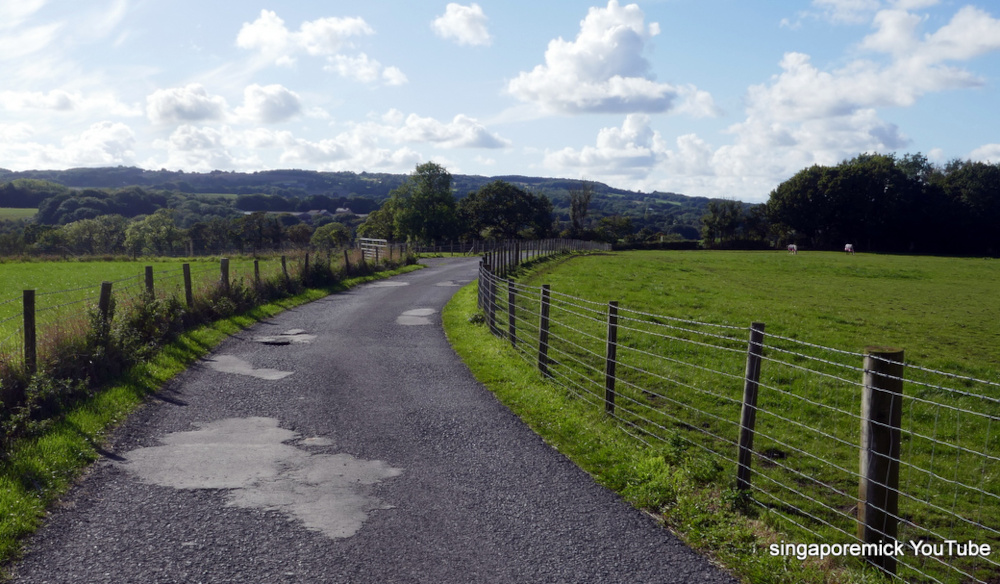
[442,283,881,584]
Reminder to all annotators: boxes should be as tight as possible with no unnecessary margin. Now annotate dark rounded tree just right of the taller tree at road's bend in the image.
[458,180,552,239]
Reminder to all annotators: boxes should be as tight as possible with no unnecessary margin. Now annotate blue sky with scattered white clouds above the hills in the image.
[0,0,1000,202]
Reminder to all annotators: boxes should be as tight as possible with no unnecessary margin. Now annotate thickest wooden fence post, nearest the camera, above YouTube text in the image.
[858,347,903,574]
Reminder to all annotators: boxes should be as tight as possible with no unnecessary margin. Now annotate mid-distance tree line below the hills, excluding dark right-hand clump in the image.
[0,162,697,256]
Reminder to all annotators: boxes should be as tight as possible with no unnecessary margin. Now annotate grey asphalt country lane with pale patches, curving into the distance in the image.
[14,259,733,583]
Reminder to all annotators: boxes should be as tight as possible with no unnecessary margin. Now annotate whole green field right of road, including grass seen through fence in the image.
[497,252,1000,582]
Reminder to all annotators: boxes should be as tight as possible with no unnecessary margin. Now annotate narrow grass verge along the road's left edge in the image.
[0,265,420,578]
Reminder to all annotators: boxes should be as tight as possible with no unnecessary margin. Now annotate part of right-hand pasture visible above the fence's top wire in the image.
[524,251,1000,381]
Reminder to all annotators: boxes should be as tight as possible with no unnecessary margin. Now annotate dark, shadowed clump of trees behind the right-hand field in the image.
[703,153,1000,255]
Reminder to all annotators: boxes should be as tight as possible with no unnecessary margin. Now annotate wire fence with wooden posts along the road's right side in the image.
[479,252,1000,582]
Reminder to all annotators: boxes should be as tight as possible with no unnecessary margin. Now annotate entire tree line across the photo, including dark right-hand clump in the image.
[0,153,1000,256]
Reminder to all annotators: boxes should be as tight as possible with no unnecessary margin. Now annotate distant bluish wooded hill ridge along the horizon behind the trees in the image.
[0,166,709,239]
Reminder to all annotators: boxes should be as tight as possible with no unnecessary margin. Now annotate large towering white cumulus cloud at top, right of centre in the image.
[507,0,704,113]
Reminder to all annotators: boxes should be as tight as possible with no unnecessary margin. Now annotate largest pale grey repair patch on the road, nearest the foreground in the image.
[122,418,403,538]
